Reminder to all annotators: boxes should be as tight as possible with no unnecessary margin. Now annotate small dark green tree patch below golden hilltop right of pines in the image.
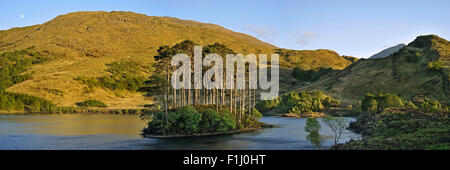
[292,67,334,82]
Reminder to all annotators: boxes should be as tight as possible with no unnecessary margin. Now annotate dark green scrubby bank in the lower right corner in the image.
[342,108,450,150]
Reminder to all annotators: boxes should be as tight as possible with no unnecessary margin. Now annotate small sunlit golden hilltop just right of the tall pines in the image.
[276,49,358,70]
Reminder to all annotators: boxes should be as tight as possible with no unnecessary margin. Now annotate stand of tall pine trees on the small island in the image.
[143,40,259,125]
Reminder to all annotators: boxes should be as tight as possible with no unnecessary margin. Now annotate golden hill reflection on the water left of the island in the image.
[0,114,145,138]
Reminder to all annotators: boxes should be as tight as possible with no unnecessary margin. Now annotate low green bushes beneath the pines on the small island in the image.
[143,105,251,136]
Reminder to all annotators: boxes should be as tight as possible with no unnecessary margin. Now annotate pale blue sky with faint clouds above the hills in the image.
[0,0,450,58]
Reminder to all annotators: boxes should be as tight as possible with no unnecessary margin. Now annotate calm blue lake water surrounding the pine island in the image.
[0,114,360,150]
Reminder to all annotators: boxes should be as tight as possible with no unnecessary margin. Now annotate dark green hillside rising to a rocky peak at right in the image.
[297,35,450,104]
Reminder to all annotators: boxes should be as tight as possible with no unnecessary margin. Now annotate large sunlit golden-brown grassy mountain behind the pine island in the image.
[0,12,352,109]
